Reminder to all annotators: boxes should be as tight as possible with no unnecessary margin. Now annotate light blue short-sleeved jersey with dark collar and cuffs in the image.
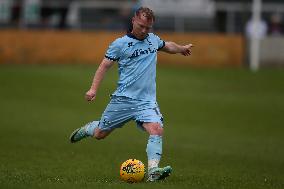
[105,33,165,102]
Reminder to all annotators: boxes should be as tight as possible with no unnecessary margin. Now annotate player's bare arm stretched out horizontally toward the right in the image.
[161,41,193,56]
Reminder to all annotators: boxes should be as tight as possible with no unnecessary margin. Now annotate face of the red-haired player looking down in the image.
[132,15,153,39]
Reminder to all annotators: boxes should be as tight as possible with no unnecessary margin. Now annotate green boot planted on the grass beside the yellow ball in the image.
[147,166,173,182]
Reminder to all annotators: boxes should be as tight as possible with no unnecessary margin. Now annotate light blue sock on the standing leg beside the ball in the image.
[146,135,162,169]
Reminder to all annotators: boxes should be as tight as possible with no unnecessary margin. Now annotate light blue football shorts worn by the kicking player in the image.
[98,96,163,131]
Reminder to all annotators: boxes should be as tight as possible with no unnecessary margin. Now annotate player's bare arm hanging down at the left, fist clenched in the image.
[85,58,114,101]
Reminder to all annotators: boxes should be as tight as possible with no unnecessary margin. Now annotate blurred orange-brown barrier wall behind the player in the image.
[0,30,244,66]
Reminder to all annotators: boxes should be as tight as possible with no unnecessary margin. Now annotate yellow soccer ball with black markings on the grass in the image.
[120,159,145,183]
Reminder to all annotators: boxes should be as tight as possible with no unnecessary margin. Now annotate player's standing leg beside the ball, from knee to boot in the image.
[143,123,172,182]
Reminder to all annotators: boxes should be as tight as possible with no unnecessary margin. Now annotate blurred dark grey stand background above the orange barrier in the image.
[0,0,284,34]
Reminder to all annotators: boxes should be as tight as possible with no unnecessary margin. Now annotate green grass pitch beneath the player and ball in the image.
[0,65,284,189]
